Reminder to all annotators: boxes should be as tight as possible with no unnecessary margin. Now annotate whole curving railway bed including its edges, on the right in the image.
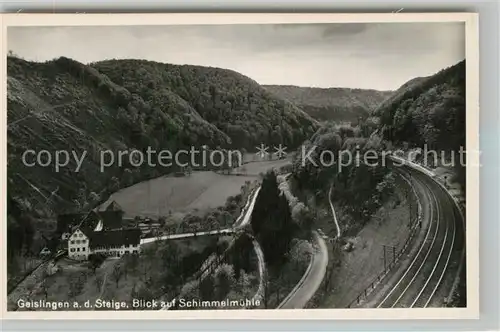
[363,160,465,308]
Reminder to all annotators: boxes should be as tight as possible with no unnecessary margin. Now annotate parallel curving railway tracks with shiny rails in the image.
[375,166,461,308]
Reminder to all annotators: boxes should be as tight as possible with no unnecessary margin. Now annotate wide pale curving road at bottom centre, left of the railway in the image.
[278,232,328,309]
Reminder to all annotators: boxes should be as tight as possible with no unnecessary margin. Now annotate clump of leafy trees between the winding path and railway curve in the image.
[293,123,394,233]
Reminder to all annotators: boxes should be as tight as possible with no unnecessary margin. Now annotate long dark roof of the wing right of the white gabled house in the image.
[89,228,141,249]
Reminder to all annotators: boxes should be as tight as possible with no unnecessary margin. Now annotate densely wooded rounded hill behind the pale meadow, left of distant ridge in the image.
[92,60,315,149]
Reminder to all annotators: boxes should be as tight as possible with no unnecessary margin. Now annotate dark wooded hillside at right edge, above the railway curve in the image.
[374,60,466,187]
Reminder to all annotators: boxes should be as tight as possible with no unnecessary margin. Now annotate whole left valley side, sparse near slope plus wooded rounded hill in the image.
[7,56,317,264]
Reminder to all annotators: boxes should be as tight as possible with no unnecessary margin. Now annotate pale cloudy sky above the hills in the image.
[7,22,465,90]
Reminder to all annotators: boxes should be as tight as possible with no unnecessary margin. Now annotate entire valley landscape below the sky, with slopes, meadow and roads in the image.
[7,50,465,310]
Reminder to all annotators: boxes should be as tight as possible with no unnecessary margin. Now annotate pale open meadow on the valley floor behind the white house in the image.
[99,160,288,218]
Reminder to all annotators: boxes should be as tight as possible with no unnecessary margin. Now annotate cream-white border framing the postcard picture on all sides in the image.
[0,13,479,320]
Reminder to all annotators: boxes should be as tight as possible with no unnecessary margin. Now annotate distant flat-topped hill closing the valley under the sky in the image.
[264,85,392,123]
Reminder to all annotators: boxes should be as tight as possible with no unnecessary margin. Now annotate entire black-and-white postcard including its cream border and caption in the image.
[1,14,480,318]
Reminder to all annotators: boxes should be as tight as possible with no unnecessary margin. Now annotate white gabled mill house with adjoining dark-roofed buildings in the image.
[57,202,141,260]
